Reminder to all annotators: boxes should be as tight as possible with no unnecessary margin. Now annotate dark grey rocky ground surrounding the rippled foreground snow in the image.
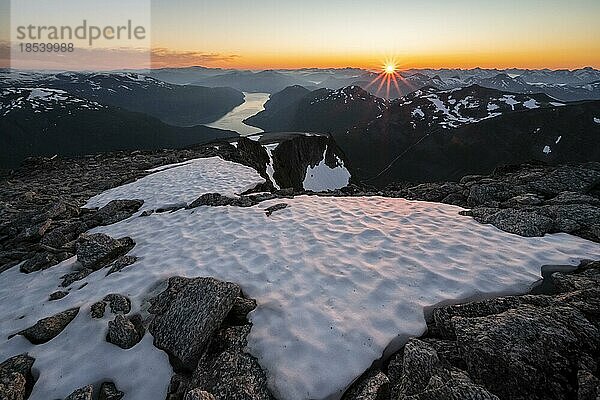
[0,140,600,400]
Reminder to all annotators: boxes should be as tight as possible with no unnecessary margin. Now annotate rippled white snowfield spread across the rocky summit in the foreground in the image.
[0,159,600,400]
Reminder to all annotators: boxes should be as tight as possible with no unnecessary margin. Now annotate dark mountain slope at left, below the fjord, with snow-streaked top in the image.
[0,89,237,168]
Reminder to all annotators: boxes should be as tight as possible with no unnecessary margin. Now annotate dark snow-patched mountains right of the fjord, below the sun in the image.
[246,85,600,185]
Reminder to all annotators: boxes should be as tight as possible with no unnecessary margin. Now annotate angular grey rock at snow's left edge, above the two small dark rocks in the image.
[77,233,135,271]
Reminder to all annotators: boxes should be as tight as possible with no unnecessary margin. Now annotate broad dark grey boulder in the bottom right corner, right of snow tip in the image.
[452,305,600,400]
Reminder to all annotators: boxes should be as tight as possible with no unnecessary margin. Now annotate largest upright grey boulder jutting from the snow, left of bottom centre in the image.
[149,277,240,370]
